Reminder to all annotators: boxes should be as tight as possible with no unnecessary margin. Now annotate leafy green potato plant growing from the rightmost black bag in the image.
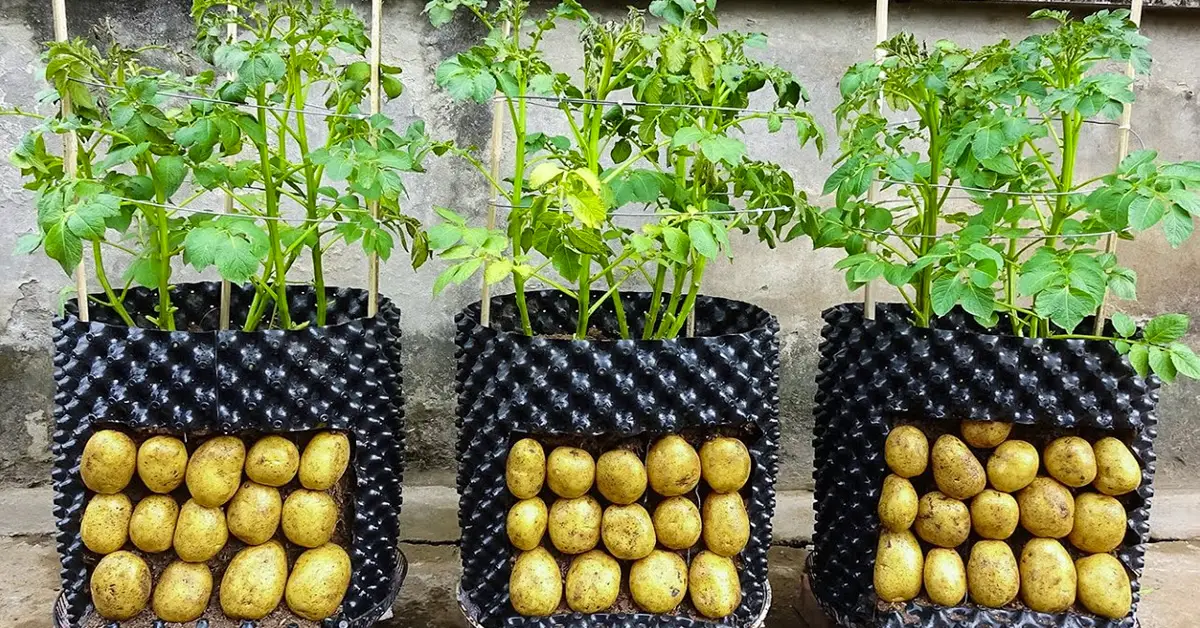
[808,11,1200,381]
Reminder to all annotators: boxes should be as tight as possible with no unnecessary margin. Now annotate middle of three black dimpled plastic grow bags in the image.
[456,291,779,628]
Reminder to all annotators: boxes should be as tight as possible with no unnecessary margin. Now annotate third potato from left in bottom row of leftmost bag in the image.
[217,540,288,620]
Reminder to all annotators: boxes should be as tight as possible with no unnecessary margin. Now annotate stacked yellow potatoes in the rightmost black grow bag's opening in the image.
[875,421,1141,618]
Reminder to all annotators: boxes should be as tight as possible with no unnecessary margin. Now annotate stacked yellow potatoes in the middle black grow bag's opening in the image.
[505,435,751,618]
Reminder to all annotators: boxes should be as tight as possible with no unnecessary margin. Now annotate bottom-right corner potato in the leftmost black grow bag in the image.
[284,543,350,622]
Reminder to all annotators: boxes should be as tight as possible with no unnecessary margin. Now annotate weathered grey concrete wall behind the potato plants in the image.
[0,0,1200,488]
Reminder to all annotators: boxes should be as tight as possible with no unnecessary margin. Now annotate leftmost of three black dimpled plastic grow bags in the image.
[53,282,406,628]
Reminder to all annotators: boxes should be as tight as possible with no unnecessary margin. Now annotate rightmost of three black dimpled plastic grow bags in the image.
[809,304,1159,628]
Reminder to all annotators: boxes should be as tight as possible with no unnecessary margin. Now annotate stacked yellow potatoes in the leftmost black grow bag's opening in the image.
[79,430,350,622]
